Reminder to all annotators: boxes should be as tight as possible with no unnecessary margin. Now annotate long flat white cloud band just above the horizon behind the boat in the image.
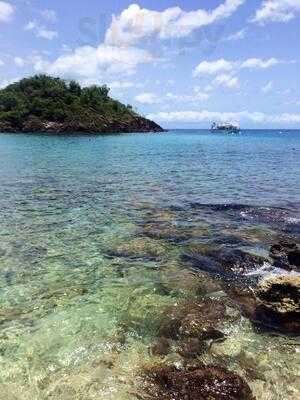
[147,110,300,124]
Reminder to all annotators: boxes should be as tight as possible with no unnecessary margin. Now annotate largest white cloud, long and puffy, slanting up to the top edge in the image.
[105,0,245,46]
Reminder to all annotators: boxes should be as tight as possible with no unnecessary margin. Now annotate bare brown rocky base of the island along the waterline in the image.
[0,116,164,133]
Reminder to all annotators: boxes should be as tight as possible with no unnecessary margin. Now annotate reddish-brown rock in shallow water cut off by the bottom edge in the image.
[142,366,254,400]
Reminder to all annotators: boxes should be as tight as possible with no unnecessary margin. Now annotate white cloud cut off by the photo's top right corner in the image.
[251,0,300,24]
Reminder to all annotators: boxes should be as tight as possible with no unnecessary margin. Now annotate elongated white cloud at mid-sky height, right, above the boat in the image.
[193,58,283,77]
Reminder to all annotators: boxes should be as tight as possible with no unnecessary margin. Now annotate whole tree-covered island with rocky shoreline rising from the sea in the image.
[0,75,164,134]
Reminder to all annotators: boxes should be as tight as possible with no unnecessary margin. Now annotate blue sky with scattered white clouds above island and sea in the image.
[0,0,300,129]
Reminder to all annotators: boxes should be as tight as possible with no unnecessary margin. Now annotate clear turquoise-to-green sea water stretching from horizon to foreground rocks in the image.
[0,131,300,400]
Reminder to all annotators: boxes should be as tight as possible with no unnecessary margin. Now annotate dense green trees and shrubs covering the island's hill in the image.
[0,75,135,125]
